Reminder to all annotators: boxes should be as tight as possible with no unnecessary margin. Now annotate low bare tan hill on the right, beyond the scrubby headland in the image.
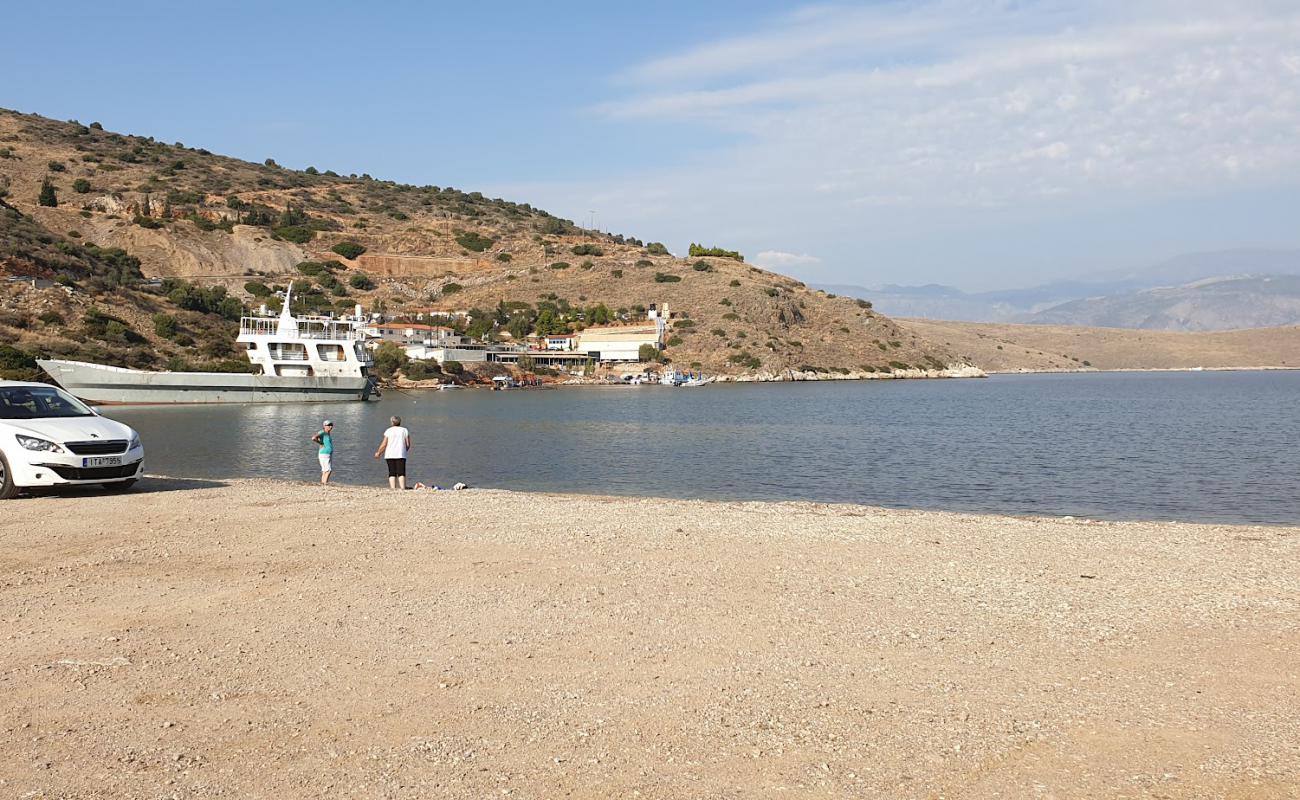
[900,320,1300,372]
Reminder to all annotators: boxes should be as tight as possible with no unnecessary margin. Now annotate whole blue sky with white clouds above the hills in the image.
[0,0,1300,290]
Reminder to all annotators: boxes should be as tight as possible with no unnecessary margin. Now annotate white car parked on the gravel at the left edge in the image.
[0,381,144,500]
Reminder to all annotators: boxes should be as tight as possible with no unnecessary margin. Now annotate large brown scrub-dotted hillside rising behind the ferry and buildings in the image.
[0,111,962,379]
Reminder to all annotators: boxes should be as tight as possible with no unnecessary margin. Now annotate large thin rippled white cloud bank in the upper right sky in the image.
[599,0,1300,207]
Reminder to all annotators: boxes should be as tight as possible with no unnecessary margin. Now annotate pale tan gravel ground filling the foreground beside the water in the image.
[0,479,1300,799]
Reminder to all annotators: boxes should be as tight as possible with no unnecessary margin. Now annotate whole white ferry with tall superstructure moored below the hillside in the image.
[38,287,378,405]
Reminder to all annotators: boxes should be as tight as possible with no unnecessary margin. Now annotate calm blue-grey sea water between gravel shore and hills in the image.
[107,372,1300,523]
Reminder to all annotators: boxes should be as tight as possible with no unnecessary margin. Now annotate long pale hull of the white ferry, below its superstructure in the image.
[36,360,374,405]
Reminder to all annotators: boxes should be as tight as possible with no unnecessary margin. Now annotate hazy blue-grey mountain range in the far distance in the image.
[819,250,1300,330]
